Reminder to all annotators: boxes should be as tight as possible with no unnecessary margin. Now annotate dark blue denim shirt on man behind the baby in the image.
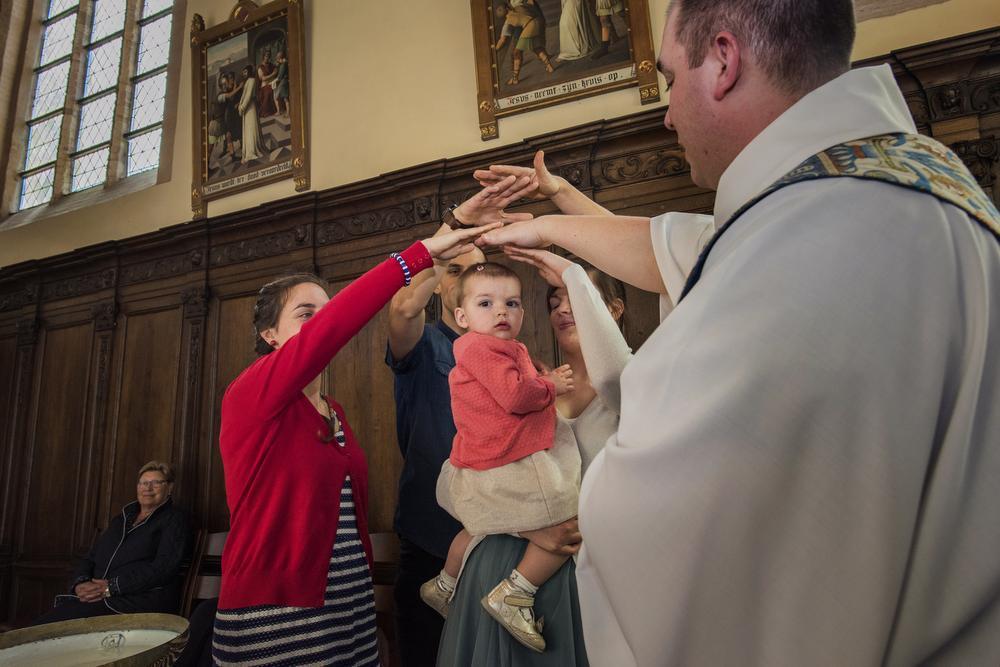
[385,321,462,558]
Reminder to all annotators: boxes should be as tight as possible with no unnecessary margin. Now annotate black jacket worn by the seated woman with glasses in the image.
[72,498,191,614]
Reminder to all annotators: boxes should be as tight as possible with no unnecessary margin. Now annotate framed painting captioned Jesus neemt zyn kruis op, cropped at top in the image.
[471,0,660,141]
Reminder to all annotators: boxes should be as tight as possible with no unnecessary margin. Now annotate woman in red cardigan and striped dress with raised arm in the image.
[212,224,499,665]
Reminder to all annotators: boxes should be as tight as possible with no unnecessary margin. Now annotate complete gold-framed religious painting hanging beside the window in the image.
[191,0,309,218]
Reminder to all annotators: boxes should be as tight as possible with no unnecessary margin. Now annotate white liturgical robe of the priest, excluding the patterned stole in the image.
[577,66,1000,667]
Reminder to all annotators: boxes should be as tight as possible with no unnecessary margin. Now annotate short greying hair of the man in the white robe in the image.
[669,0,855,94]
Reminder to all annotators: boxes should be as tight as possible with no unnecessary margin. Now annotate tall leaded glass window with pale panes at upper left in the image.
[15,0,174,209]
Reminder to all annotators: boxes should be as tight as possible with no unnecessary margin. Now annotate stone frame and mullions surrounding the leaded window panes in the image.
[0,0,187,230]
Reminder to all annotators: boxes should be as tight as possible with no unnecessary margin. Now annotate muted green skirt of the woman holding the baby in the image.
[437,535,589,667]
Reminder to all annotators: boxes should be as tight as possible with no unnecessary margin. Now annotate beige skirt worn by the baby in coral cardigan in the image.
[437,420,580,535]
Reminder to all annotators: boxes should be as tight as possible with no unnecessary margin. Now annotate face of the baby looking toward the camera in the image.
[455,277,524,340]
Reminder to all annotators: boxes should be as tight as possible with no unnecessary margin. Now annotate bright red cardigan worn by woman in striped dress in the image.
[219,243,432,609]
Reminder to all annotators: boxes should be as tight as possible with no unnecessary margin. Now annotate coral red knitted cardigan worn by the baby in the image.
[448,332,556,470]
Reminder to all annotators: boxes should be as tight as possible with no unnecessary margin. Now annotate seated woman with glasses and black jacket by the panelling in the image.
[35,461,191,625]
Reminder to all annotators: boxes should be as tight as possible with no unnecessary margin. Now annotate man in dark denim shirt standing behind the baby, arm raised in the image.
[385,176,531,667]
